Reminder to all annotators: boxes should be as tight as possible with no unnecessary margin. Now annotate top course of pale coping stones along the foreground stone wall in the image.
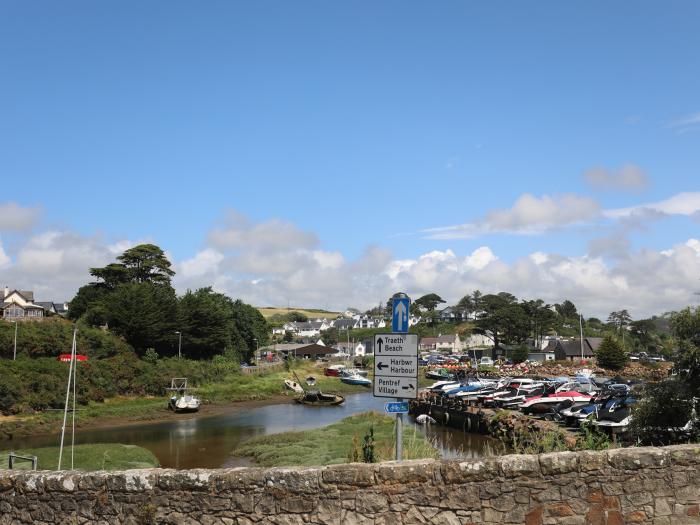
[0,444,700,494]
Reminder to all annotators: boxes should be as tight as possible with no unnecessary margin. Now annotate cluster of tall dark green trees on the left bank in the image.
[68,244,269,360]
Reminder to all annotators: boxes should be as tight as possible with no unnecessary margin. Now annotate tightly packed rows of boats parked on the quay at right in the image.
[428,373,636,433]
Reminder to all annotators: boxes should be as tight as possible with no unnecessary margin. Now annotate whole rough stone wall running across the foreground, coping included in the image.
[0,445,700,525]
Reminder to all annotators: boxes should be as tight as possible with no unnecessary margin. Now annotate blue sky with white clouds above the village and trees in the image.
[0,0,700,318]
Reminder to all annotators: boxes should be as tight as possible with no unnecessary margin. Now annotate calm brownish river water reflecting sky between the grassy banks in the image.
[14,393,498,468]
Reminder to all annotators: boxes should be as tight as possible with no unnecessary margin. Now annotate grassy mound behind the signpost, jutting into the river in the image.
[234,412,438,467]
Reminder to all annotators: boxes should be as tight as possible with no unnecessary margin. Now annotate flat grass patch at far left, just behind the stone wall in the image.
[0,443,159,470]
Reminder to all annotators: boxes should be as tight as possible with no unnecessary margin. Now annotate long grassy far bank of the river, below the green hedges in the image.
[0,361,368,439]
